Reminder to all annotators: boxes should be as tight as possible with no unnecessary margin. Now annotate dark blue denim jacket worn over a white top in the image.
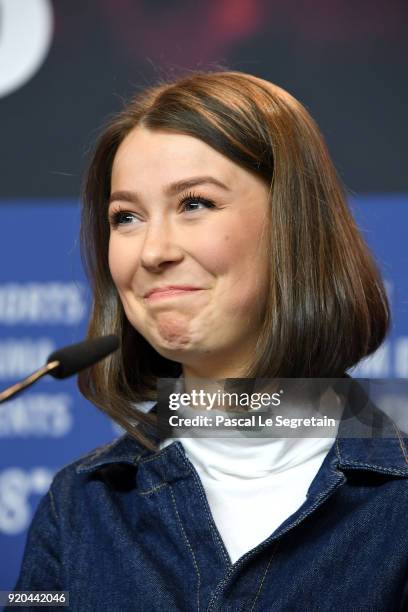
[9,380,408,612]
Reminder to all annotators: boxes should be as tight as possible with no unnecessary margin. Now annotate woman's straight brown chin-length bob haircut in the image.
[78,70,390,449]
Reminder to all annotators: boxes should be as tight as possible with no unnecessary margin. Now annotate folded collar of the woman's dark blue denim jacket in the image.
[76,375,408,477]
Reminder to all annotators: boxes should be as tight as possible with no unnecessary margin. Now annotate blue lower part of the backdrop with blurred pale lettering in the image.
[0,195,408,590]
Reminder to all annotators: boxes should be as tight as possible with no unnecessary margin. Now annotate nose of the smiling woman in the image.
[141,218,183,271]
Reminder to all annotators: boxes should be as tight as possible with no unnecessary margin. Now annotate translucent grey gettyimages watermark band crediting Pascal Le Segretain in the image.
[157,378,408,438]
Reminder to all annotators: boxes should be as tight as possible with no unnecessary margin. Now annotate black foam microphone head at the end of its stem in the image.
[47,335,119,378]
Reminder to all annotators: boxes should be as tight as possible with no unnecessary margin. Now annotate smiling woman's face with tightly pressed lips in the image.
[109,127,268,378]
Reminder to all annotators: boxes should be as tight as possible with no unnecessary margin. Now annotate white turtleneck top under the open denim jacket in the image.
[160,382,342,563]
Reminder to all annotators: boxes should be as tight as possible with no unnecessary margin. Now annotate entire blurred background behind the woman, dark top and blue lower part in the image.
[0,0,408,590]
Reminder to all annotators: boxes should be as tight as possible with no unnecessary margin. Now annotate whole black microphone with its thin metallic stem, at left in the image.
[0,335,119,404]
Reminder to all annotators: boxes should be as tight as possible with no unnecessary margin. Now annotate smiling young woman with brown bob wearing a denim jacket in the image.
[10,72,408,612]
